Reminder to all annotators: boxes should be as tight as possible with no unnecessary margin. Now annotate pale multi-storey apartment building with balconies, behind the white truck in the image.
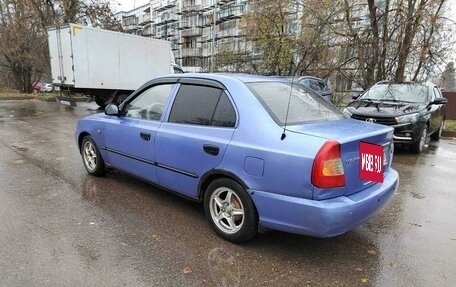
[115,0,252,72]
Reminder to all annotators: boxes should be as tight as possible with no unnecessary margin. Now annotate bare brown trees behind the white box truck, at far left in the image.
[0,0,121,93]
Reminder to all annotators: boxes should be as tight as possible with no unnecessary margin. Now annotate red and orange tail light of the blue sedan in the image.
[312,141,345,188]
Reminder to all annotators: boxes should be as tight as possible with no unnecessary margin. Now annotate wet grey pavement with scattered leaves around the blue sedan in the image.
[0,101,456,286]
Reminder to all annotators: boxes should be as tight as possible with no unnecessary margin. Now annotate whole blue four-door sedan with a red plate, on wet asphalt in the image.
[75,74,399,242]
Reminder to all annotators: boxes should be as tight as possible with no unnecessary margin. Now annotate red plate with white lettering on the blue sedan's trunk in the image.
[359,142,386,182]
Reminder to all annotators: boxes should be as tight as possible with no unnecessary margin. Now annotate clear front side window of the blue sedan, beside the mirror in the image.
[124,84,173,121]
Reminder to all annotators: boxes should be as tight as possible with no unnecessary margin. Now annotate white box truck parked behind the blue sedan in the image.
[48,24,182,107]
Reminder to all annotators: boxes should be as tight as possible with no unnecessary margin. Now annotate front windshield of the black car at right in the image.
[360,83,428,103]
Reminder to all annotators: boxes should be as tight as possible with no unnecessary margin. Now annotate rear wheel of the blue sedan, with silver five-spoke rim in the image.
[204,178,258,242]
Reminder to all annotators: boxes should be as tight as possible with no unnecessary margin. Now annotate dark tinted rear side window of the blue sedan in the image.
[169,84,236,127]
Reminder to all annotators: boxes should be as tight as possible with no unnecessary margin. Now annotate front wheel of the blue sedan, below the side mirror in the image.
[81,136,105,176]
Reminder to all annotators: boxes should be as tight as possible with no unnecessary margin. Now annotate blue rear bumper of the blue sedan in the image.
[250,169,399,237]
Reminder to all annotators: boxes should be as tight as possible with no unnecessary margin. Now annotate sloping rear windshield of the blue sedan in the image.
[247,82,344,125]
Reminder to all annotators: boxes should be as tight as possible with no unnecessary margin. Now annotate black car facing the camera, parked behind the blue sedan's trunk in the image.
[344,82,447,153]
